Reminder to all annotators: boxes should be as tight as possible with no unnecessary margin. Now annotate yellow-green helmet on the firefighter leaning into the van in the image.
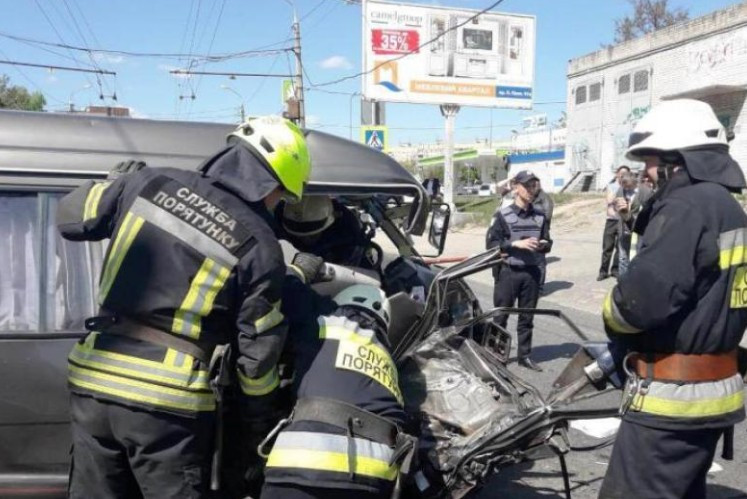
[228,116,311,201]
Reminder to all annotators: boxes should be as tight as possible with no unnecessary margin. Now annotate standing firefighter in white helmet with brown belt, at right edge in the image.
[600,99,747,498]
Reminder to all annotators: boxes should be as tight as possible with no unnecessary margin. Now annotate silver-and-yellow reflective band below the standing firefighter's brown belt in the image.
[630,374,744,418]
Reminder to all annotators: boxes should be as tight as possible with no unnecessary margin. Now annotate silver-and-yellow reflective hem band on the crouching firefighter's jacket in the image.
[267,431,398,481]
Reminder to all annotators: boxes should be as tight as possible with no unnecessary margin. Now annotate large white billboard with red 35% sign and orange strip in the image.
[363,0,536,109]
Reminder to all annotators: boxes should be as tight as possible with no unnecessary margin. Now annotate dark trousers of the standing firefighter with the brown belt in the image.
[599,420,724,499]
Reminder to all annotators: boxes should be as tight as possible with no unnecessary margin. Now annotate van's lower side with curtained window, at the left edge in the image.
[0,190,103,497]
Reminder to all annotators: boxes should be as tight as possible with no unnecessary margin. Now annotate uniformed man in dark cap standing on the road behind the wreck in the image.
[485,170,552,371]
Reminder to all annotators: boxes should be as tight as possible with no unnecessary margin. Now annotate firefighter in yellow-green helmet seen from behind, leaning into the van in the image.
[57,117,318,499]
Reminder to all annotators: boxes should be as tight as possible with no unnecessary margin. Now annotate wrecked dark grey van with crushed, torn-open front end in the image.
[0,111,616,497]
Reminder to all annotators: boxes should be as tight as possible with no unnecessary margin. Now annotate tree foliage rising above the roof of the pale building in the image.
[615,0,690,43]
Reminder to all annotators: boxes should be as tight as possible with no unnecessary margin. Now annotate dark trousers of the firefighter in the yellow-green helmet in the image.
[69,394,214,499]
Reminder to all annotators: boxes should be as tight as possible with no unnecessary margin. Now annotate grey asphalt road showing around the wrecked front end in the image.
[470,279,747,499]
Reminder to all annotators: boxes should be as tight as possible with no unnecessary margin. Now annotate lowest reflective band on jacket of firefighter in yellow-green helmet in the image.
[68,364,215,412]
